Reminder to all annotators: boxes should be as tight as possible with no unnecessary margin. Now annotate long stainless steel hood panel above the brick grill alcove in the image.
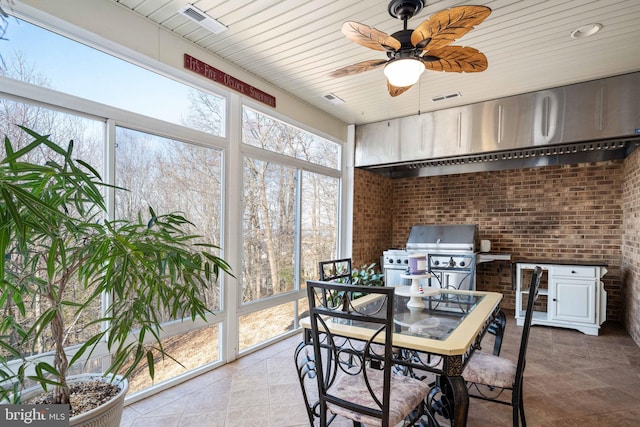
[355,73,640,166]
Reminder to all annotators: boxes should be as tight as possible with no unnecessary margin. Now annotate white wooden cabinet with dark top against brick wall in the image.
[515,262,607,335]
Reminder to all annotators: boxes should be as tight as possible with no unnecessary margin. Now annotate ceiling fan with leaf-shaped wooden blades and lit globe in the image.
[330,0,491,96]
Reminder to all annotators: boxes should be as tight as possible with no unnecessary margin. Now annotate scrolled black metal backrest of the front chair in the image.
[307,281,395,426]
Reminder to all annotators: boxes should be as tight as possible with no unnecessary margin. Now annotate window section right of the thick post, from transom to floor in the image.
[239,108,340,350]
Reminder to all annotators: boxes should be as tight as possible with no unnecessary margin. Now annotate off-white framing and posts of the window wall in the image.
[0,12,353,403]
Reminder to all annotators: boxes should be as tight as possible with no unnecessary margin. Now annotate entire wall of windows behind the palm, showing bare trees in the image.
[0,8,341,398]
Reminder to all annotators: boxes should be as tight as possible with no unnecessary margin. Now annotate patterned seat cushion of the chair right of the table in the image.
[462,351,516,388]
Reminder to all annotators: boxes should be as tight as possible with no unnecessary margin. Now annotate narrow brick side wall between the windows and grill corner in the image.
[351,169,392,270]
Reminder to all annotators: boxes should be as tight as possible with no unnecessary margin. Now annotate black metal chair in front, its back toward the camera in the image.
[307,281,429,427]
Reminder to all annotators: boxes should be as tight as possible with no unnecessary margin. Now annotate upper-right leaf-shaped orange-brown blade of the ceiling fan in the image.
[411,6,491,51]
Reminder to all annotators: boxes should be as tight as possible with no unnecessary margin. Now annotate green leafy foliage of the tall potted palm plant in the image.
[0,127,231,426]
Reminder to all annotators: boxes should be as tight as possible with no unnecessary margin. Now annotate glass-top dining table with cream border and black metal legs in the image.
[296,286,502,426]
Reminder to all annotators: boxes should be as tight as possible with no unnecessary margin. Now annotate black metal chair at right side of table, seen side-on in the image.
[463,267,542,427]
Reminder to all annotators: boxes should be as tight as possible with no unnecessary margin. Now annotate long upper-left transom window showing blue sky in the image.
[0,18,226,136]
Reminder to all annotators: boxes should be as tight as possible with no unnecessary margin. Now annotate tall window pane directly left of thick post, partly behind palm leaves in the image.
[115,127,222,310]
